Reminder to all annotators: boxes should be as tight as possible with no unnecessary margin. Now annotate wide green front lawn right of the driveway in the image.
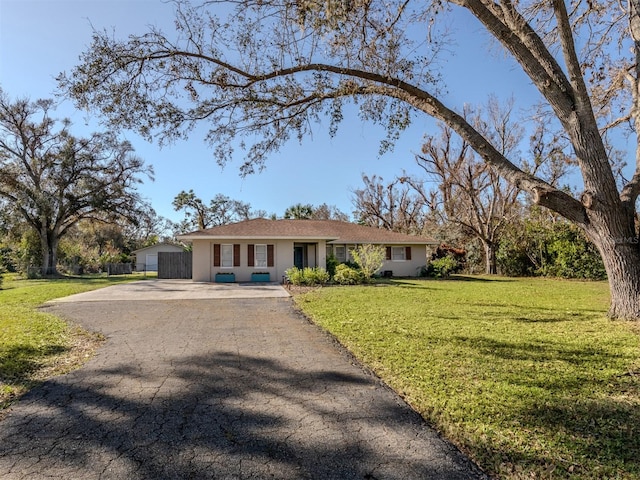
[296,277,640,479]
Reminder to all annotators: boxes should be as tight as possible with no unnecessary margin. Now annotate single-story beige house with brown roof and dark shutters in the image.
[178,218,438,282]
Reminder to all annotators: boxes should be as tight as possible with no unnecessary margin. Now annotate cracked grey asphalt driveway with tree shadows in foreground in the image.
[0,284,484,480]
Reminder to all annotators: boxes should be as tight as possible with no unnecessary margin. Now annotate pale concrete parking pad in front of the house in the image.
[54,279,289,303]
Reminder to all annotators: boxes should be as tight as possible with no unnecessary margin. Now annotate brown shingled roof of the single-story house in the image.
[178,218,438,245]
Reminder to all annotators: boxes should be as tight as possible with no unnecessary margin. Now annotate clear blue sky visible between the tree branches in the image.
[0,0,535,220]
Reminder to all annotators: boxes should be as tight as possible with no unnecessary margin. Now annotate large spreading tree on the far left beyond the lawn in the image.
[0,90,152,274]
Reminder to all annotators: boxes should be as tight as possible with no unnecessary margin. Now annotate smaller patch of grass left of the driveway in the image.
[0,275,154,411]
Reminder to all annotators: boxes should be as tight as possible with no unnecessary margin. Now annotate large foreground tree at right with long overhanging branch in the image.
[60,0,640,319]
